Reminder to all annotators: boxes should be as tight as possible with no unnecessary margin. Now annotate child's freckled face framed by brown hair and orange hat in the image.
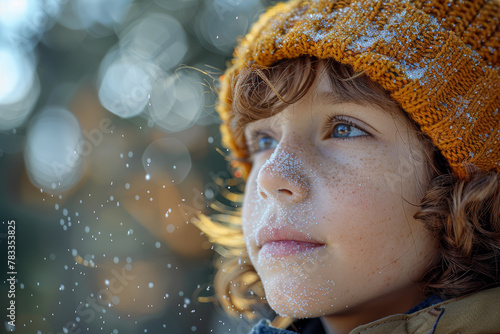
[242,72,437,318]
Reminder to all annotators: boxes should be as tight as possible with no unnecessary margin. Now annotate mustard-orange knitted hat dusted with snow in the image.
[217,0,500,179]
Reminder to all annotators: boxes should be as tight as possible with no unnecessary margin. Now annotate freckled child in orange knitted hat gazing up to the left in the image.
[193,0,500,333]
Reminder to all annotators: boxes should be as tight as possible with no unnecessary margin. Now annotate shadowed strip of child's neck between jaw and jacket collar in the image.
[321,290,425,334]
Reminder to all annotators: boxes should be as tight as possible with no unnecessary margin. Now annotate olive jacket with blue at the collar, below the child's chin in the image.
[249,287,500,334]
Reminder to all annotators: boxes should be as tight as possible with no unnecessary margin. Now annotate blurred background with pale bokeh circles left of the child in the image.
[0,0,275,334]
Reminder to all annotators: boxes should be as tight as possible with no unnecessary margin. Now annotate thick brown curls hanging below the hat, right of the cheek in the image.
[414,167,500,298]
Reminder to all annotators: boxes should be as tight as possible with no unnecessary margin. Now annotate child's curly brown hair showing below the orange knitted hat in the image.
[194,57,500,327]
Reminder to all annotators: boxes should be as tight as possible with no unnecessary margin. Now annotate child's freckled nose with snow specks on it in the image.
[256,151,309,203]
